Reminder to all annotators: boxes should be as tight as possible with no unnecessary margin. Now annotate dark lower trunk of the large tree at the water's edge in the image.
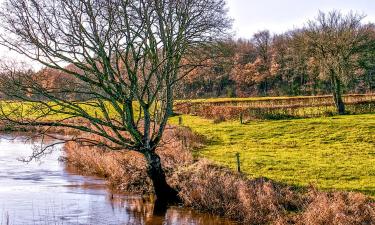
[144,150,179,206]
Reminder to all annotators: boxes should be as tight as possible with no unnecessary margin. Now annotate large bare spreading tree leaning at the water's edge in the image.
[0,0,231,204]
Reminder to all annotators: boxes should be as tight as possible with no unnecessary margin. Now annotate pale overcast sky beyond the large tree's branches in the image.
[0,0,375,68]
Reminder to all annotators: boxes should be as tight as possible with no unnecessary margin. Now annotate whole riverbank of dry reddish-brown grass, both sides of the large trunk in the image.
[65,120,375,225]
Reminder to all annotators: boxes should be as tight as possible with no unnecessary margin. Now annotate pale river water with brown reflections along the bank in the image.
[0,136,234,225]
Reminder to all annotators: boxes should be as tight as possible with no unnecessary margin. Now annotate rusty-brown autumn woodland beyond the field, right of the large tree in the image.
[178,11,375,98]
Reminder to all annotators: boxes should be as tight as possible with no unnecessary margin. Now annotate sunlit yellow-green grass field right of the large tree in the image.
[171,114,375,196]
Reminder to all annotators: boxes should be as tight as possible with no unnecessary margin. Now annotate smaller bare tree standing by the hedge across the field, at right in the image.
[305,11,372,114]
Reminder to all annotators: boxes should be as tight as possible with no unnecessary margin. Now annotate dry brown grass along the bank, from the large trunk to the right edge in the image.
[172,160,375,225]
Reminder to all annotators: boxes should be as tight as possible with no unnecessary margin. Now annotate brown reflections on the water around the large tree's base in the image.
[109,195,235,225]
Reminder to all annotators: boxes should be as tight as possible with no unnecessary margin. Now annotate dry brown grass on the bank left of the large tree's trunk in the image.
[64,142,152,193]
